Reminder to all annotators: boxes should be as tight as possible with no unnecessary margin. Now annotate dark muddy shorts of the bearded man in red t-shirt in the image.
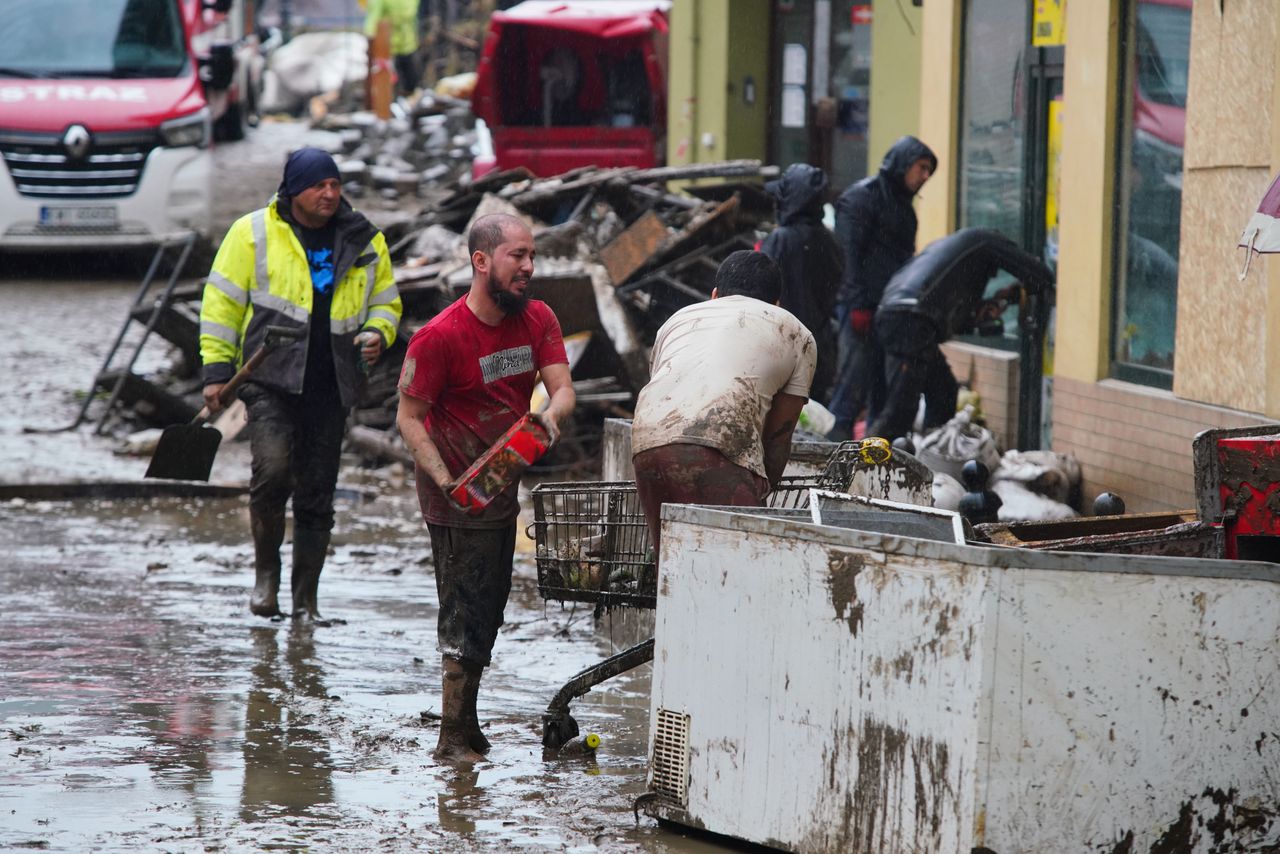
[426,520,516,667]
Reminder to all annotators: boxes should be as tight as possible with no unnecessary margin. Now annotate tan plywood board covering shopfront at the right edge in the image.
[1174,0,1280,415]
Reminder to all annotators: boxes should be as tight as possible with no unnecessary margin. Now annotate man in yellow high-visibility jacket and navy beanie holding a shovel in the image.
[200,149,401,620]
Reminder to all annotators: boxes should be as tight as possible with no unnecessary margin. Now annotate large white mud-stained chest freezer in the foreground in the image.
[641,497,1280,854]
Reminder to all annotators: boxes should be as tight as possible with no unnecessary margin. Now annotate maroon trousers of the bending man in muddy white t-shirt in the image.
[632,443,769,554]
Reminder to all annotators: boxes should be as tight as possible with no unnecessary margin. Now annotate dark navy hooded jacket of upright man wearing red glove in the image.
[836,136,938,311]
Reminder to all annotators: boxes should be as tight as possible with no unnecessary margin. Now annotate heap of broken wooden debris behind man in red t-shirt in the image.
[340,160,776,467]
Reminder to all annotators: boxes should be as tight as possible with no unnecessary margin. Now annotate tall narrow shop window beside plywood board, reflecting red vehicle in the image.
[1112,0,1192,388]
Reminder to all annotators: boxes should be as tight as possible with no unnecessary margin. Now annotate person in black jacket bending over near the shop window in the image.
[867,228,1053,440]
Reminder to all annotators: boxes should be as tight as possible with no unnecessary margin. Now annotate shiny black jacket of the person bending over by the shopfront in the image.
[877,228,1053,346]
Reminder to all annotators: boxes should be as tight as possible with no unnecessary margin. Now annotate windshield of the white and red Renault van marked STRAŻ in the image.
[0,0,188,78]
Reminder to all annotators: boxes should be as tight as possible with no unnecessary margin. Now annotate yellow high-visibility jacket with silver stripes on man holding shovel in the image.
[200,200,401,406]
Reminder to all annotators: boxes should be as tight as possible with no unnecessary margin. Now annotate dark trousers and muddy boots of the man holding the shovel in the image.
[239,383,347,618]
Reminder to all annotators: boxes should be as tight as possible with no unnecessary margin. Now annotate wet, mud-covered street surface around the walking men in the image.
[0,124,718,851]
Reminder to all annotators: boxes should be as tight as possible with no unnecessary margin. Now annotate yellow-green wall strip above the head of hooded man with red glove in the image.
[867,0,921,166]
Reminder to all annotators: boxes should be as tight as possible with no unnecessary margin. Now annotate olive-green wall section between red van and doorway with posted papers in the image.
[667,0,769,165]
